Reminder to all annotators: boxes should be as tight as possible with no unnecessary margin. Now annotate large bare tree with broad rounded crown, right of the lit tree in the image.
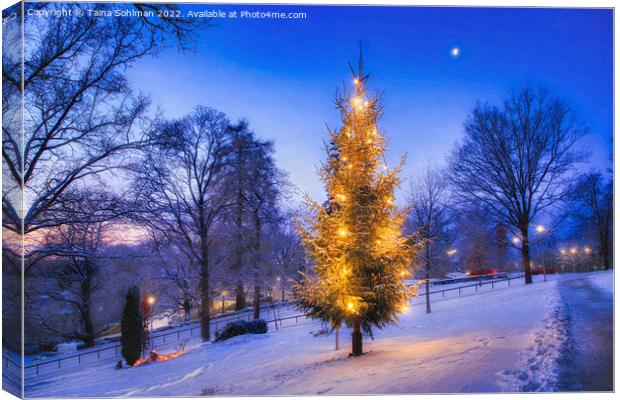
[450,88,586,283]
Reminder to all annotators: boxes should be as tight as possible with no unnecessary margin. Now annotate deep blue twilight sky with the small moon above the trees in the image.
[123,5,613,203]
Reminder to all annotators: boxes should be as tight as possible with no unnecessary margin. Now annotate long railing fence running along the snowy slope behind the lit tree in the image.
[7,273,523,376]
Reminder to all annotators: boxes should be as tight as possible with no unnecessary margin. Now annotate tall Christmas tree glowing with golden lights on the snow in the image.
[296,55,416,355]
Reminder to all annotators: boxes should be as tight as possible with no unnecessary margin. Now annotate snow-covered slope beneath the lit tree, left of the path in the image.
[26,272,613,397]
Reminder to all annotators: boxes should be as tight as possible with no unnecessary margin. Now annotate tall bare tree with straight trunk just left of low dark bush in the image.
[133,107,229,341]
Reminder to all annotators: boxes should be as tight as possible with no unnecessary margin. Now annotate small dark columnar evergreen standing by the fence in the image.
[121,286,143,365]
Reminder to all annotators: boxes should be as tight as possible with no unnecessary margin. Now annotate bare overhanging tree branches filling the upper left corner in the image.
[2,3,203,233]
